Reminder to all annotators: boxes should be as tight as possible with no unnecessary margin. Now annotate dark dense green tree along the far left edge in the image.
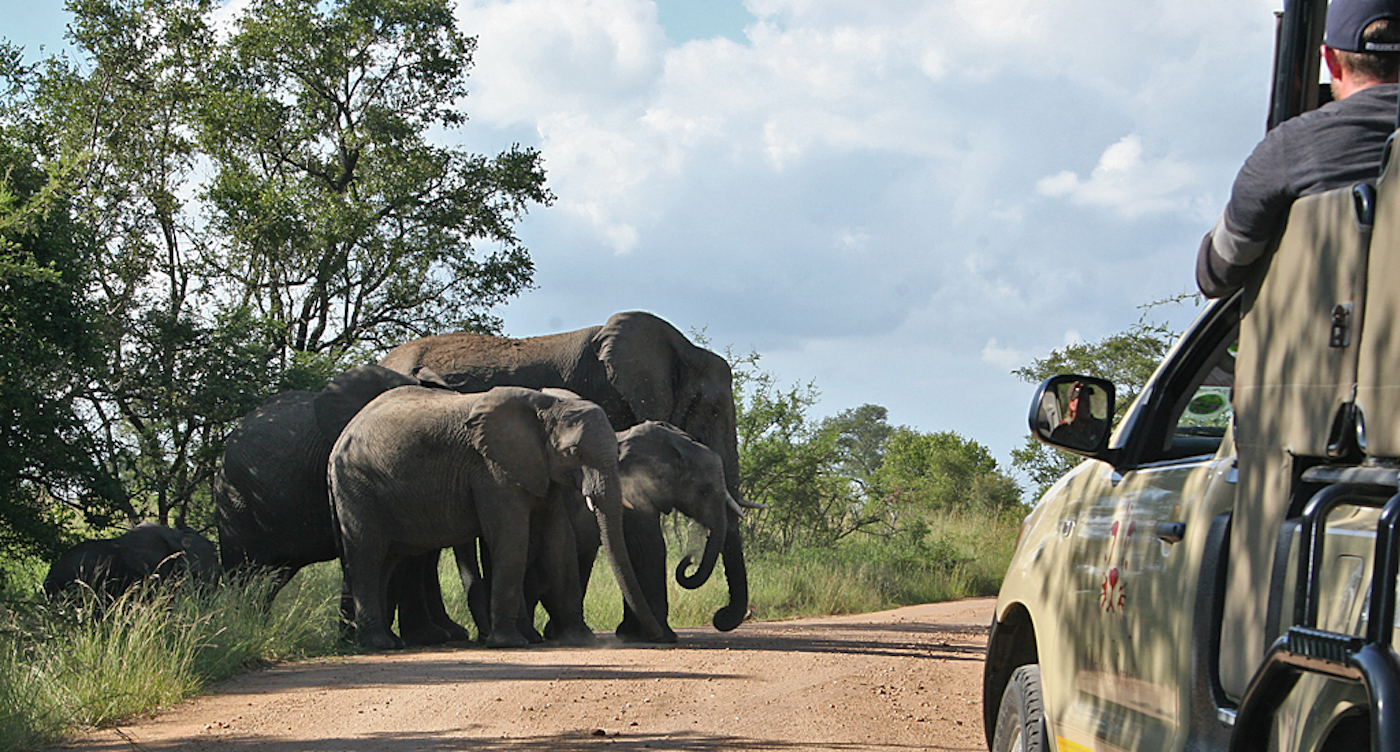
[0,64,123,560]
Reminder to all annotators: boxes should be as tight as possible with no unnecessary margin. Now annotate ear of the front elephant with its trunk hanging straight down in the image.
[466,387,550,496]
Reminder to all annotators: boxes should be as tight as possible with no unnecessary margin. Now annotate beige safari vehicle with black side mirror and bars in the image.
[983,0,1400,752]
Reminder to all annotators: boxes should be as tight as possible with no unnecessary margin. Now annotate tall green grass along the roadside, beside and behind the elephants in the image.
[0,514,1019,751]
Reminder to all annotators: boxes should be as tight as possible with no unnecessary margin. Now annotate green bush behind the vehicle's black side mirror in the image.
[1011,295,1191,497]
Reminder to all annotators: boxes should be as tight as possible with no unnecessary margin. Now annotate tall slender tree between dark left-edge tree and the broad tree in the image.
[23,0,273,524]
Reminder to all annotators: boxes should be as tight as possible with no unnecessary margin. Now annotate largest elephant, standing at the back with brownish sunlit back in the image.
[379,311,749,639]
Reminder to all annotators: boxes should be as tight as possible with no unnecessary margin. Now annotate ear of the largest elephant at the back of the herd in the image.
[594,311,697,420]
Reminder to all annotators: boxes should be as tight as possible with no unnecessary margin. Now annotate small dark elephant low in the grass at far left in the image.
[43,522,220,599]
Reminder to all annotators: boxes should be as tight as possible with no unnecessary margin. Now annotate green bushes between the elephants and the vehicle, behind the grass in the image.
[729,354,1021,552]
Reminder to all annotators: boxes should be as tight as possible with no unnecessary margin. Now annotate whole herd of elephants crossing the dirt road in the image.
[45,312,749,648]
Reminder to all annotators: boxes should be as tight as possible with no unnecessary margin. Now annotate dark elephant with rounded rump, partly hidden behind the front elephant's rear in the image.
[214,365,470,644]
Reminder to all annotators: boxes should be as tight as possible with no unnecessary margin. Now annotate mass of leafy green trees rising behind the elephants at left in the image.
[0,0,552,553]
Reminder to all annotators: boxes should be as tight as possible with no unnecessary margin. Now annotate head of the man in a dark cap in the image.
[1323,0,1400,99]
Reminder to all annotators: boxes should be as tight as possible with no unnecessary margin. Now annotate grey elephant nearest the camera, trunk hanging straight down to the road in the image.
[329,387,661,648]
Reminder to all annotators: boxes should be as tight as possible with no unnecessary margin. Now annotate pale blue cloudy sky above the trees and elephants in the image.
[0,0,1282,481]
